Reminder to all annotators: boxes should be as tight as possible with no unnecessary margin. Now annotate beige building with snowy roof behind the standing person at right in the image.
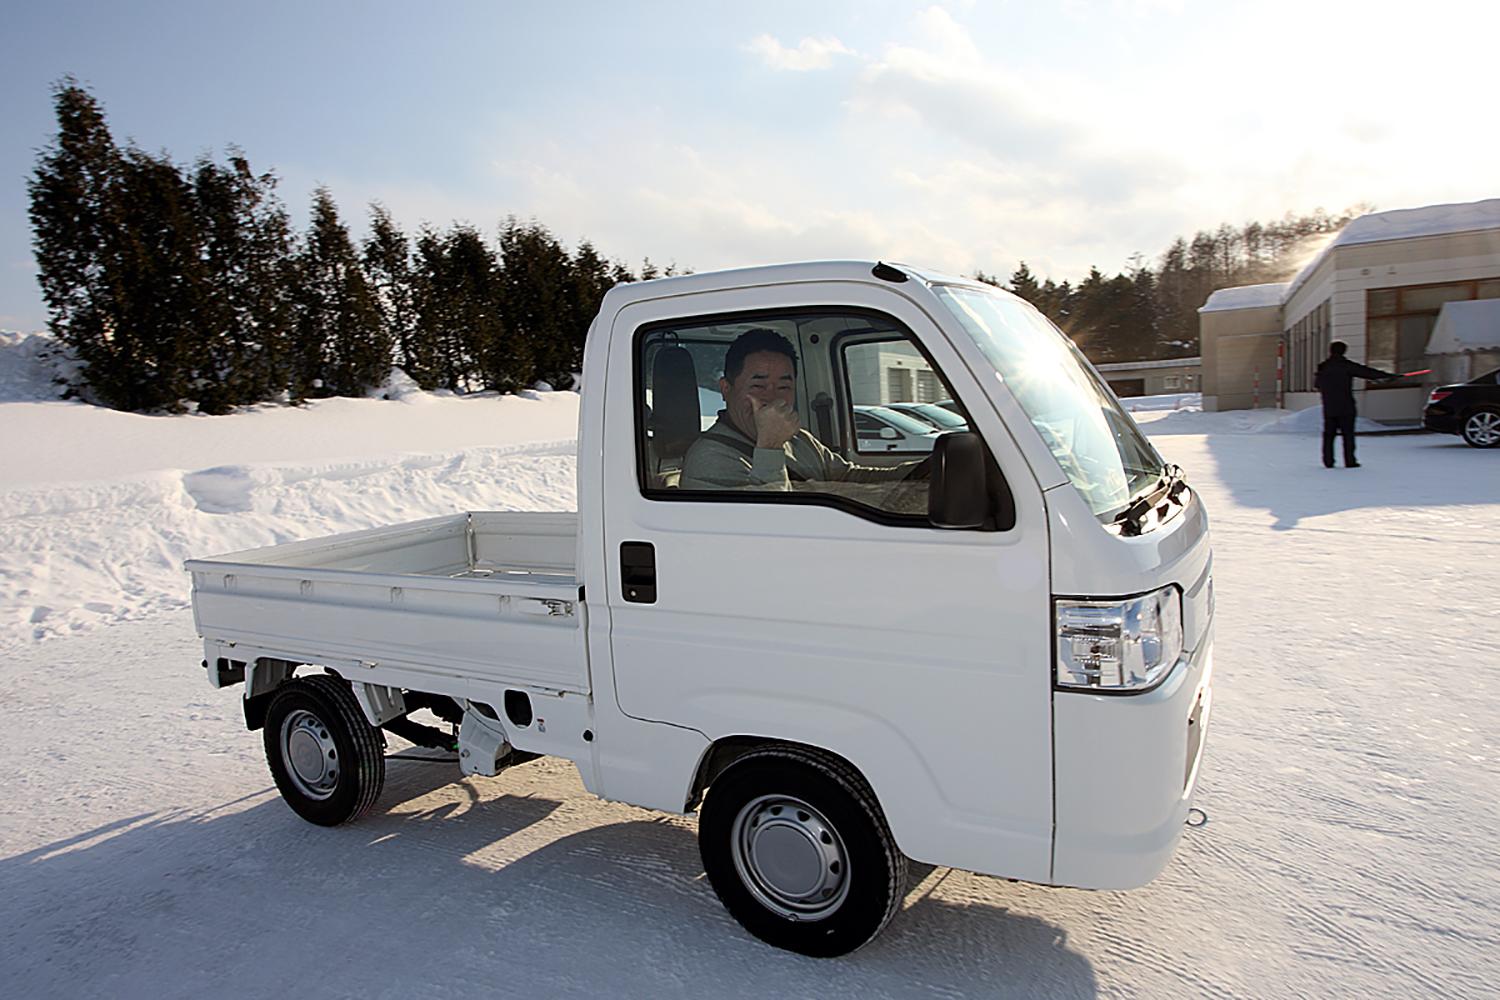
[1199,198,1500,423]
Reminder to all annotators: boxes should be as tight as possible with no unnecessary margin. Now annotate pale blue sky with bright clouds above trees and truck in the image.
[0,0,1500,331]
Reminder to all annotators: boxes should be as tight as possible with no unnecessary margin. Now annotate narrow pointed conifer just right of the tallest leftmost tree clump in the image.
[291,187,390,399]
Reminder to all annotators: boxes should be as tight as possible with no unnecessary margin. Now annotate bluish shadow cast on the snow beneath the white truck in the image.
[0,763,1097,997]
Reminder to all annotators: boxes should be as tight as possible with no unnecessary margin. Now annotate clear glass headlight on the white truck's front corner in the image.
[1056,586,1182,693]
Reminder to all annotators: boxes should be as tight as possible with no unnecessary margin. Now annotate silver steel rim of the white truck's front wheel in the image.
[731,795,849,921]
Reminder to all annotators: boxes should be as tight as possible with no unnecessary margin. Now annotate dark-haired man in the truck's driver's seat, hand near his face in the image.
[681,327,927,490]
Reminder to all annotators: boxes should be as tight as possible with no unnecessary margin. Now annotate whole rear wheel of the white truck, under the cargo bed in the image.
[261,675,386,826]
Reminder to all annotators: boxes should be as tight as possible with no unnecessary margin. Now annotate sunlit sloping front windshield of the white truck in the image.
[935,285,1164,520]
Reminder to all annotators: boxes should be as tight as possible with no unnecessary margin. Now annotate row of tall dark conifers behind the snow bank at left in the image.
[29,79,672,412]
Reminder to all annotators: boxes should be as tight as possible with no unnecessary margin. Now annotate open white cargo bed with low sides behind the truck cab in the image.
[188,513,588,693]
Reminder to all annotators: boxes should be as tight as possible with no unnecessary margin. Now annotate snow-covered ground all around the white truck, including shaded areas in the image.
[0,340,1500,999]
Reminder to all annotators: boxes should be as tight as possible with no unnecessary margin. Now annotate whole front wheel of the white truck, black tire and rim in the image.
[698,747,906,958]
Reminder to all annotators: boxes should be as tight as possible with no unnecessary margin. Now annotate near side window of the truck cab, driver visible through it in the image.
[636,310,966,526]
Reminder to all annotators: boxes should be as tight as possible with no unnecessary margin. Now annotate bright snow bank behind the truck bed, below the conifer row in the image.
[0,383,579,645]
